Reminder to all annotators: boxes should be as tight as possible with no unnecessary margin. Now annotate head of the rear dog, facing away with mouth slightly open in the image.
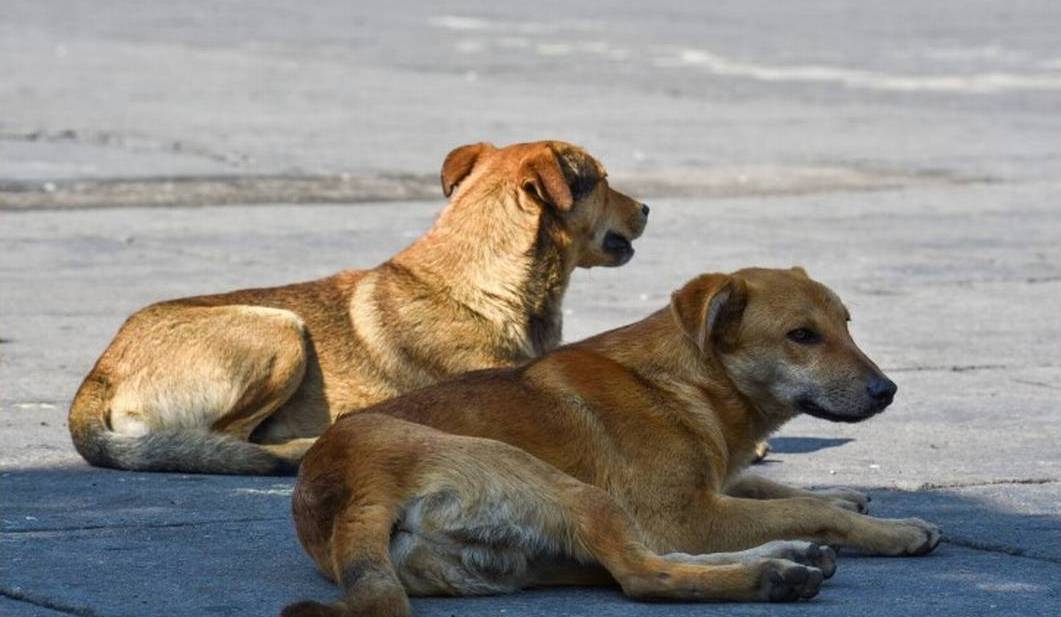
[441,141,648,267]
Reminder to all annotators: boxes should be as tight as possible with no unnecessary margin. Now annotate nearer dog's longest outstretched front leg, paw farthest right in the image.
[705,495,941,556]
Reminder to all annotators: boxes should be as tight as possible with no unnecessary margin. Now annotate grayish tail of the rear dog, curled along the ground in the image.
[68,371,298,475]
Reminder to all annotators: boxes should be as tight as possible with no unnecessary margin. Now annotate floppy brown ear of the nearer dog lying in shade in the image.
[671,275,748,353]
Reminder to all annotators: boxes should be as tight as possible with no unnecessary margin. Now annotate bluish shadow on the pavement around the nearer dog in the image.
[0,466,1061,617]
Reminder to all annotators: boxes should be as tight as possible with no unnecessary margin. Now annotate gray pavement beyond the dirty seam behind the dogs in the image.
[6,0,1061,196]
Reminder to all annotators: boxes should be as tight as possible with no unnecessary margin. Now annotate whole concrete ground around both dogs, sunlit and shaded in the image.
[0,0,1061,617]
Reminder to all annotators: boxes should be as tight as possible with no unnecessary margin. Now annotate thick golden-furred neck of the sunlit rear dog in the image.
[392,192,574,363]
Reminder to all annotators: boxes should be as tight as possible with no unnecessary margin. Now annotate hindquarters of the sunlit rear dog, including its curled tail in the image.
[70,304,308,474]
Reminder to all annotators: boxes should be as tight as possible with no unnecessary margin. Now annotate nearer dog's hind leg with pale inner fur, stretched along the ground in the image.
[392,460,824,601]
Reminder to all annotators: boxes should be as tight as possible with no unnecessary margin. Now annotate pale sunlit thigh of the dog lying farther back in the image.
[100,305,306,441]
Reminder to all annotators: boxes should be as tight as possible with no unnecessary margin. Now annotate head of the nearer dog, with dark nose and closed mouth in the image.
[672,267,897,422]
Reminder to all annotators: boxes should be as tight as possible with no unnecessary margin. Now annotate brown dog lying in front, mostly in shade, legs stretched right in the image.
[285,268,940,617]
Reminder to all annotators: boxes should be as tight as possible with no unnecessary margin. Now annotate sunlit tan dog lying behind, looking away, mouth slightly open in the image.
[70,142,648,474]
